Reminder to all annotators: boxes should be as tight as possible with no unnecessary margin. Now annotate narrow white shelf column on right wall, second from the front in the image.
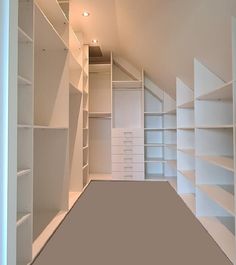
[176,78,196,213]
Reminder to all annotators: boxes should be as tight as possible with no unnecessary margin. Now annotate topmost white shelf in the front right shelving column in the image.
[197,81,233,101]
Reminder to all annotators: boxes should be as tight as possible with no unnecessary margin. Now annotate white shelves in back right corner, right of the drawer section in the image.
[144,78,177,189]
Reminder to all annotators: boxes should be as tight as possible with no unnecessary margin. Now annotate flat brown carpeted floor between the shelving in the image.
[33,181,232,265]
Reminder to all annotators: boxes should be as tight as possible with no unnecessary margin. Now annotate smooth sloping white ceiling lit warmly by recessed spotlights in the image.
[71,0,236,97]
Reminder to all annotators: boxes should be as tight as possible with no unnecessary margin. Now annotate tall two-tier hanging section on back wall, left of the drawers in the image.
[88,56,112,180]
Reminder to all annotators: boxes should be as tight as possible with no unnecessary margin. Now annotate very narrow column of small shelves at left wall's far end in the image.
[83,45,89,185]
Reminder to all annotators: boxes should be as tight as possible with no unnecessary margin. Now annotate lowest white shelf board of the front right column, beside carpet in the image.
[198,217,235,262]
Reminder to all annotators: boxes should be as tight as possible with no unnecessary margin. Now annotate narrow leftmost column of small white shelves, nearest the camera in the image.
[16,0,34,264]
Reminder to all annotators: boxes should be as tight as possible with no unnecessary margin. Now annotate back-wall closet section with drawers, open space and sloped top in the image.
[112,55,144,180]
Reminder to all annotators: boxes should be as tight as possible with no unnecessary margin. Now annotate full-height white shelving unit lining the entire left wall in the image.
[16,0,88,265]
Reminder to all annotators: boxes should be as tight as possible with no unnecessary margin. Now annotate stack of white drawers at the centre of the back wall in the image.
[112,129,144,180]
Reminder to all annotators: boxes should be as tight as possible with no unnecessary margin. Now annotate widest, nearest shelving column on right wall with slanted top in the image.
[194,59,235,262]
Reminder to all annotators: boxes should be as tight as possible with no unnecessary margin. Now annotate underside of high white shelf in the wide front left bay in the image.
[35,1,68,51]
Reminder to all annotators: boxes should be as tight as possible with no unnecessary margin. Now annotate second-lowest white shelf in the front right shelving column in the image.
[198,185,235,215]
